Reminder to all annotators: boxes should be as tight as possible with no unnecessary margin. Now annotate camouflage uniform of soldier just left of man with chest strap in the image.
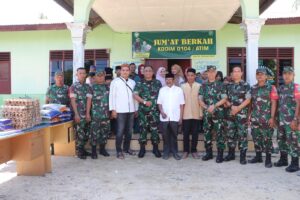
[91,84,110,146]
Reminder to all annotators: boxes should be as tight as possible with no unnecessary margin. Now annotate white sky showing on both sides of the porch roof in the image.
[0,0,300,25]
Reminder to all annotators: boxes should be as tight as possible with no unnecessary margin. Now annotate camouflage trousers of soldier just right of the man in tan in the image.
[203,111,225,149]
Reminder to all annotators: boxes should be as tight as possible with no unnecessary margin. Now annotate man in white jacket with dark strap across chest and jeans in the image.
[109,65,137,159]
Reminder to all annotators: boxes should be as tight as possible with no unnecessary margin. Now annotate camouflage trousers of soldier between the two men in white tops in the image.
[139,113,160,144]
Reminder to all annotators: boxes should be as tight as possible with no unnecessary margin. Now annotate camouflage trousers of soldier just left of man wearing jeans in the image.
[90,119,110,146]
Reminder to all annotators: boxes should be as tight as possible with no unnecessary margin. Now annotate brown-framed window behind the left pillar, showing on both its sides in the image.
[50,49,109,85]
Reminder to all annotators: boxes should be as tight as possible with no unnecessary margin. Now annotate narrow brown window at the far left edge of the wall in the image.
[0,52,11,94]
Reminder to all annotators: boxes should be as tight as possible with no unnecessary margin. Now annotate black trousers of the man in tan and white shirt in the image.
[183,119,200,153]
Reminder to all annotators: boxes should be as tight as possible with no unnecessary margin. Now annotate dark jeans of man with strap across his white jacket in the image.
[116,113,134,152]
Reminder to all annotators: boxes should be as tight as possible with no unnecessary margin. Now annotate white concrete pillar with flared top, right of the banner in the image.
[241,18,265,86]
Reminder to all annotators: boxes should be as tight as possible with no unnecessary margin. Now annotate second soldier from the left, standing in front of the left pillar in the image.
[70,68,92,159]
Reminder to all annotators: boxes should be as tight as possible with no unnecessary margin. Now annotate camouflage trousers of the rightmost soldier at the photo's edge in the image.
[277,125,300,157]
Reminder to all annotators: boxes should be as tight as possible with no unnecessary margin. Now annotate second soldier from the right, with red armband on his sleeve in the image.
[248,68,278,168]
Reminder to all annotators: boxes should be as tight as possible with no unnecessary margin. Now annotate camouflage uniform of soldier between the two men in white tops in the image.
[134,79,161,144]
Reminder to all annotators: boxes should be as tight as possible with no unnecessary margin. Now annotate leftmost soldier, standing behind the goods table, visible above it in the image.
[46,72,70,106]
